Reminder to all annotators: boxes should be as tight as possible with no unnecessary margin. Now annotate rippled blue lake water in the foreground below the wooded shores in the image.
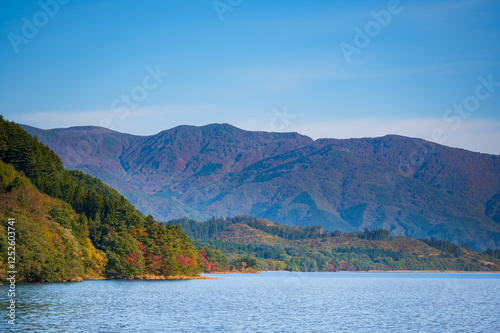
[0,273,500,333]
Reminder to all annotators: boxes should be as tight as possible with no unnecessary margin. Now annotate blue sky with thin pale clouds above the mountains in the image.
[0,0,500,154]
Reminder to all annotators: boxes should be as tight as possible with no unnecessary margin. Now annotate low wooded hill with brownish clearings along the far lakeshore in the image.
[169,216,500,271]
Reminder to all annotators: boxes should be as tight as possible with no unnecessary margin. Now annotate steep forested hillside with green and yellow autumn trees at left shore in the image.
[0,116,203,281]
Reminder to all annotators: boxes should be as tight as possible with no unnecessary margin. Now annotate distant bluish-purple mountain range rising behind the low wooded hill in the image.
[21,124,500,250]
